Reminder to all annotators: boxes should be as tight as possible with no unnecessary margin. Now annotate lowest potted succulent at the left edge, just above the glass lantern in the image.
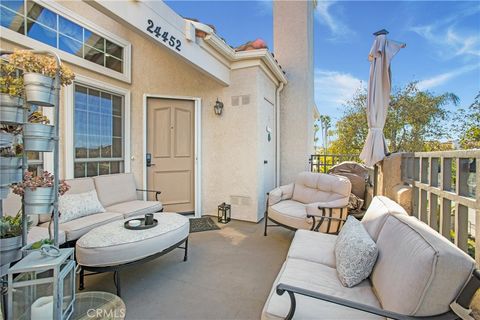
[0,210,31,265]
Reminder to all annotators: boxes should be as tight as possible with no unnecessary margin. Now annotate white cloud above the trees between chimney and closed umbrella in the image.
[315,69,367,114]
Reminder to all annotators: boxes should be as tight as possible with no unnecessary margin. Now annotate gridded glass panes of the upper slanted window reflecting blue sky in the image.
[0,0,124,73]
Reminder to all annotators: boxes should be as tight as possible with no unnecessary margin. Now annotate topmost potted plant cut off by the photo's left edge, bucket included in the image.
[0,62,23,124]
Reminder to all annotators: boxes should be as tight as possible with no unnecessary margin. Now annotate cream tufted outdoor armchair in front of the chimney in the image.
[264,172,352,236]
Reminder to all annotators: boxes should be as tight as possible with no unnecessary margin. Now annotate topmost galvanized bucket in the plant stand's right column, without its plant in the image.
[23,72,57,107]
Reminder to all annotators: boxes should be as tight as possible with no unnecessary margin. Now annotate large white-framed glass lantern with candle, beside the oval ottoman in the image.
[7,248,75,320]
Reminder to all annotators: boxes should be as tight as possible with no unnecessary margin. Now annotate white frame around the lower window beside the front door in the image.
[64,75,131,179]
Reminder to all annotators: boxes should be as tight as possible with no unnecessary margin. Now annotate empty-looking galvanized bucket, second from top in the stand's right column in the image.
[23,123,55,152]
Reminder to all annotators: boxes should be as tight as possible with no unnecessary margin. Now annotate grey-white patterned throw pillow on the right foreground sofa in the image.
[335,216,378,288]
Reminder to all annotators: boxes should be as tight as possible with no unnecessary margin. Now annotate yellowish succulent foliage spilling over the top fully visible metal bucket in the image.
[9,50,75,86]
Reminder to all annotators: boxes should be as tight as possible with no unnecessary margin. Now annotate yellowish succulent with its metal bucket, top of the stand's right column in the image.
[9,50,75,106]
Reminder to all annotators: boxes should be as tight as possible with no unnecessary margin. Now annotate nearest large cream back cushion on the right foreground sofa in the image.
[371,215,475,316]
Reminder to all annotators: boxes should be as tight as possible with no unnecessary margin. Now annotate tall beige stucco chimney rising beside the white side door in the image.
[273,0,315,184]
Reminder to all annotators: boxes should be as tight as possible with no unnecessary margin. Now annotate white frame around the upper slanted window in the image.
[0,0,132,83]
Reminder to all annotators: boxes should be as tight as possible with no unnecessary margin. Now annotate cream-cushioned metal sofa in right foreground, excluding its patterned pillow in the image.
[262,196,479,320]
